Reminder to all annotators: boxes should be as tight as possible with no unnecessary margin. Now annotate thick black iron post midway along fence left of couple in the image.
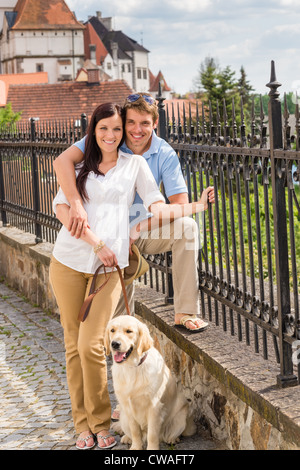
[30,118,43,243]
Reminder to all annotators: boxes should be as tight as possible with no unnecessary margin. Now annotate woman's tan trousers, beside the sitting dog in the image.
[50,257,121,434]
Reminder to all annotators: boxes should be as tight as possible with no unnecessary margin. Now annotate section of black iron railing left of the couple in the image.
[0,115,87,243]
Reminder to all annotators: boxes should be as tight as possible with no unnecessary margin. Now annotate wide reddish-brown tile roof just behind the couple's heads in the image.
[7,80,132,121]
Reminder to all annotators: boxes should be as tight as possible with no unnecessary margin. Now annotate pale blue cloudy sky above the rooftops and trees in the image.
[66,0,300,98]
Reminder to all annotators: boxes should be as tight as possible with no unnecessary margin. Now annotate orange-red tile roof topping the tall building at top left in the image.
[12,0,85,30]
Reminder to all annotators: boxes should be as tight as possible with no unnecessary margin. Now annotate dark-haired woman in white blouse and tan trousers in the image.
[50,103,210,449]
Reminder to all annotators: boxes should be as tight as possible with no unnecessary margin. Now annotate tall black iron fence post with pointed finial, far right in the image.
[266,61,298,388]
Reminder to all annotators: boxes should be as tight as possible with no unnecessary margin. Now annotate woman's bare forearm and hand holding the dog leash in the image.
[56,204,118,267]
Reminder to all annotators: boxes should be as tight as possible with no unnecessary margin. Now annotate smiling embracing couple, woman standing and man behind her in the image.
[50,94,214,449]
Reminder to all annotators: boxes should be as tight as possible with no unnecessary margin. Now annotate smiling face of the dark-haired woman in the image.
[95,114,123,153]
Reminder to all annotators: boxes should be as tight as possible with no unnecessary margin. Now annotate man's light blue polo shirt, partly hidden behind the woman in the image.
[74,131,187,224]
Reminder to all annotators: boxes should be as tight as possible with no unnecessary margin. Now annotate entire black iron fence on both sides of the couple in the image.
[0,60,300,387]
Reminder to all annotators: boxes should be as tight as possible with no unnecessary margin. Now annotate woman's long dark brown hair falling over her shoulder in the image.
[76,103,124,201]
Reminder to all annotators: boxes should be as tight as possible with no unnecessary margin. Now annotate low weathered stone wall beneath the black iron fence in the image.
[0,227,300,450]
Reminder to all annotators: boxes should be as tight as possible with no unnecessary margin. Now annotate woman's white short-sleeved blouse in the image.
[53,151,164,273]
